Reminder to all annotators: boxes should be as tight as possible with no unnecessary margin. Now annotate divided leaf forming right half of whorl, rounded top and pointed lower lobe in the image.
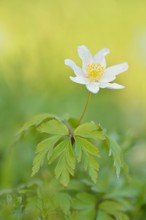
[74,122,105,183]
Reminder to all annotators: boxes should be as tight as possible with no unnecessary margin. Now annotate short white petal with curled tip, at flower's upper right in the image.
[93,48,110,67]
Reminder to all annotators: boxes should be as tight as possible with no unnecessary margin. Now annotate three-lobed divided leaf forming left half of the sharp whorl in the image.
[32,119,75,186]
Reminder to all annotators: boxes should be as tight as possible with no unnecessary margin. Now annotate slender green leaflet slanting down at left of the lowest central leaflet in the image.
[32,136,60,176]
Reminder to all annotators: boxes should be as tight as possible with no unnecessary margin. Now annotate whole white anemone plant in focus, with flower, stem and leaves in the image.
[19,46,128,189]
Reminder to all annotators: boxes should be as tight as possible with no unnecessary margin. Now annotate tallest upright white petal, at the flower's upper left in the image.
[78,45,93,73]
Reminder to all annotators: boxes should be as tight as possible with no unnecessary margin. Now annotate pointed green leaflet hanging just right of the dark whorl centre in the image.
[75,137,99,183]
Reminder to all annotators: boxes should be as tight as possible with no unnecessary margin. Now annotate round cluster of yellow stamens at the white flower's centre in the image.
[87,64,105,82]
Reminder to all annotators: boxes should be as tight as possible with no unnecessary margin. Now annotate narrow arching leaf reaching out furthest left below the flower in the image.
[17,113,55,135]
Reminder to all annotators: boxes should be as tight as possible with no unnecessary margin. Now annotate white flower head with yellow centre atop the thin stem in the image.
[65,46,128,93]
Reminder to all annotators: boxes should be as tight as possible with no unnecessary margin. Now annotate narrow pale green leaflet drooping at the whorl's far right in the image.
[108,137,123,178]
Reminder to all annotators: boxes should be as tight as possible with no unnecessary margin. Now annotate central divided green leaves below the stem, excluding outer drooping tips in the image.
[30,117,108,186]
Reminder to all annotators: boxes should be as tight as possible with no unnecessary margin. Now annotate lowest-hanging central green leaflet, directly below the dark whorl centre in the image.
[49,138,75,186]
